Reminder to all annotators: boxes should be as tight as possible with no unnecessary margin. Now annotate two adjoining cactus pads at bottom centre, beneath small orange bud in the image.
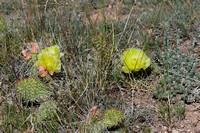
[82,109,124,133]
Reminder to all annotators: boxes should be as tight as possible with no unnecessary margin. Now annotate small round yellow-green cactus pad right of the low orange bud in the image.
[103,109,124,127]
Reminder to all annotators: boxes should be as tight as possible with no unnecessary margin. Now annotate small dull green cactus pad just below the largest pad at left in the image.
[33,101,57,123]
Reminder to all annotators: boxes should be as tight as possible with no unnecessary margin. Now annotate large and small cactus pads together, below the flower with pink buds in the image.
[17,78,57,123]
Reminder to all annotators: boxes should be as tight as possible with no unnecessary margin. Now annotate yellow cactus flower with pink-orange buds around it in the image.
[35,45,64,75]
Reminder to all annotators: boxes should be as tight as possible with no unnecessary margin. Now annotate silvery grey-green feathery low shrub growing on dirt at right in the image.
[154,36,200,103]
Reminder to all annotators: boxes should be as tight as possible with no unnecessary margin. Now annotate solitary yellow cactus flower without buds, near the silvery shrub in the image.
[122,48,151,73]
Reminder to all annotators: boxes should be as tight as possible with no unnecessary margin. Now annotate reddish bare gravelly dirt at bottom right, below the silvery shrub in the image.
[122,93,200,133]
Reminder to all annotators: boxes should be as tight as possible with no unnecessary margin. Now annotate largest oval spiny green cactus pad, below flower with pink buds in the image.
[17,78,51,102]
